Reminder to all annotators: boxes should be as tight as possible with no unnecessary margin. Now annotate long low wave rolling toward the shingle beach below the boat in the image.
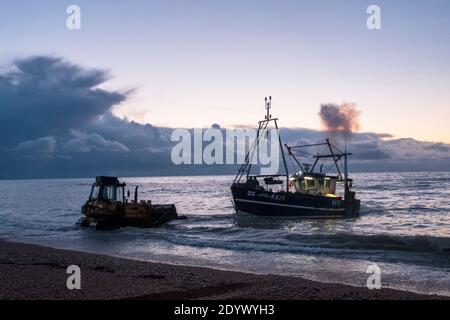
[132,219,450,256]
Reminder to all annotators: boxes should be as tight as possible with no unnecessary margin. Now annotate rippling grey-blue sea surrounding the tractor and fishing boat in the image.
[0,172,450,296]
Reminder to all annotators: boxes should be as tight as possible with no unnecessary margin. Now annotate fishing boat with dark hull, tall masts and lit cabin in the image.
[231,97,360,218]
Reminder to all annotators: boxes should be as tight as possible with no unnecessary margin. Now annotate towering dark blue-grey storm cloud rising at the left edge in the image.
[0,56,126,146]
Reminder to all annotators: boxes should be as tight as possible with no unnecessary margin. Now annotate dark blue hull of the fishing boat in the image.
[231,184,360,219]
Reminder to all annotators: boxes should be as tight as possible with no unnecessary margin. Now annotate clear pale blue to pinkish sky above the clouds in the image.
[0,0,450,142]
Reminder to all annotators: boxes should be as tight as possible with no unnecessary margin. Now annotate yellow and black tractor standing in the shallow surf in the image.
[81,176,181,230]
